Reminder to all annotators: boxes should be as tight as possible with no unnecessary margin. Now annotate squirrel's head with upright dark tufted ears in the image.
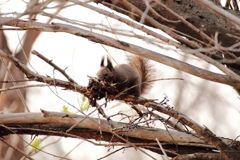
[97,57,114,82]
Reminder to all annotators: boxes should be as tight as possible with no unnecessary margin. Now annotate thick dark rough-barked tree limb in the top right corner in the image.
[94,0,240,46]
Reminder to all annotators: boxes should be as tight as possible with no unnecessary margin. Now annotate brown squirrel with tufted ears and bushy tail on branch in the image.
[97,56,154,97]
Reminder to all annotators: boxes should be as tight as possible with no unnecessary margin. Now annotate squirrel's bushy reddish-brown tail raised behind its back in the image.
[128,56,155,94]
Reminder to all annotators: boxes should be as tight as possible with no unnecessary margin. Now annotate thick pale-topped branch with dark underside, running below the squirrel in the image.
[0,111,221,156]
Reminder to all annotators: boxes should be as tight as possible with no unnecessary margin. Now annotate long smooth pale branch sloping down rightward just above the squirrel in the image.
[1,20,240,88]
